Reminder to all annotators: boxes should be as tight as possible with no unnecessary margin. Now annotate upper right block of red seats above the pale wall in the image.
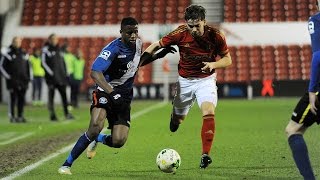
[224,0,316,22]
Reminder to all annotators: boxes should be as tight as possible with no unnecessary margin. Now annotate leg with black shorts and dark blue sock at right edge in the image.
[285,93,318,179]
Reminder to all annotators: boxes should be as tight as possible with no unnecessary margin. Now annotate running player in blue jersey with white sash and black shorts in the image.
[58,17,173,175]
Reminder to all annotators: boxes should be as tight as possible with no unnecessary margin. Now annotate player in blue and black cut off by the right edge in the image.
[286,0,320,180]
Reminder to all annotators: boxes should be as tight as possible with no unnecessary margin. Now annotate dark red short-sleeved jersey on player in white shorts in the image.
[160,25,229,78]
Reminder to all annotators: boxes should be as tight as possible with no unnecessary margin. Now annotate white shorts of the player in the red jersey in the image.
[172,73,218,115]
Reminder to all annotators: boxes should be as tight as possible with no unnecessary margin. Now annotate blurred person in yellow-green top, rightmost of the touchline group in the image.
[70,49,85,108]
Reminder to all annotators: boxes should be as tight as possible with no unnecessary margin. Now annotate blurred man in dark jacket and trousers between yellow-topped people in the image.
[42,34,74,121]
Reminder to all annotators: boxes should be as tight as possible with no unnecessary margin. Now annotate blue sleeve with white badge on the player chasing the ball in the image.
[91,46,117,72]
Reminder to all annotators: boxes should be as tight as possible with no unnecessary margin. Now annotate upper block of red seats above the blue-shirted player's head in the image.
[21,0,190,26]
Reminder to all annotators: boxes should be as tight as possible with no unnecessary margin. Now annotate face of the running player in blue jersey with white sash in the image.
[120,25,138,45]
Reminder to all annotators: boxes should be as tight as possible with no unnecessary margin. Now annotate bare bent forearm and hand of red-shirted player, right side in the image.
[201,52,232,72]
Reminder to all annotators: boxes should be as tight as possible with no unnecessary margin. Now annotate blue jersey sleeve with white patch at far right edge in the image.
[308,13,320,92]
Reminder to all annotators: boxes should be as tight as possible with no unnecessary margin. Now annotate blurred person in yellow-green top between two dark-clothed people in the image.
[30,48,44,106]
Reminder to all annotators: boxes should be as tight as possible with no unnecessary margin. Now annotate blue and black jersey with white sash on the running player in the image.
[91,38,142,91]
